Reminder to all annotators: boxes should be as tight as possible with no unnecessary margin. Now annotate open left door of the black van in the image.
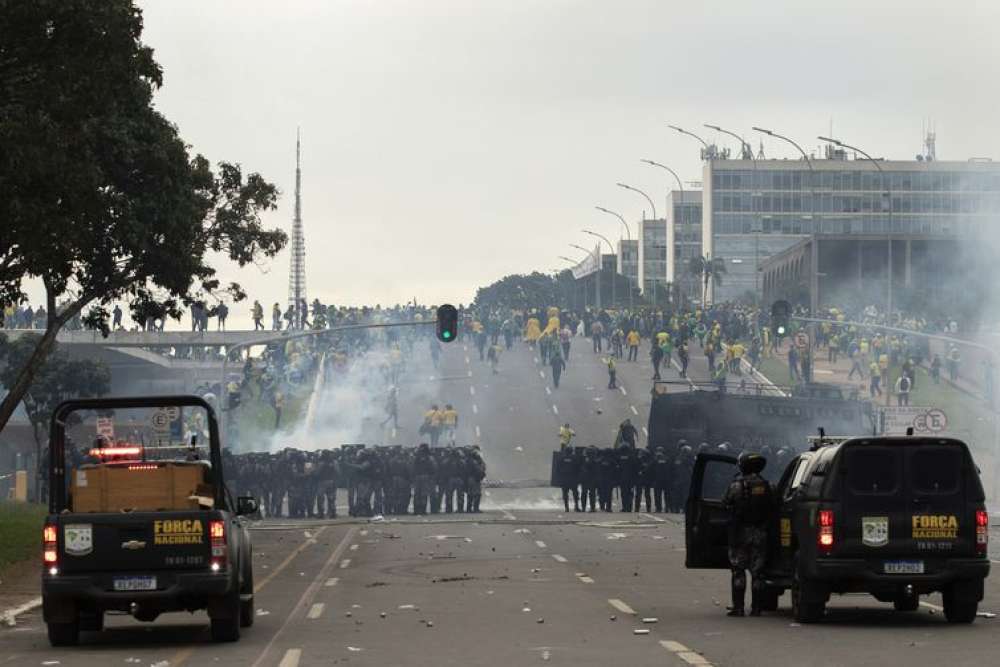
[684,454,739,570]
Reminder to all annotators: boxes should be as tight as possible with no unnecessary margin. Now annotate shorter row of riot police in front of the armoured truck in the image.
[551,439,797,513]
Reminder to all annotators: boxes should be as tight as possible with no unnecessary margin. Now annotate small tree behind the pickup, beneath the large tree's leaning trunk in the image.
[0,334,111,498]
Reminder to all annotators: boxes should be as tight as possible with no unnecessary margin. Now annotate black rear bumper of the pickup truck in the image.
[42,571,235,622]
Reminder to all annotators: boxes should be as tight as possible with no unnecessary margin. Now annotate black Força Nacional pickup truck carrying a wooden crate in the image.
[42,396,257,646]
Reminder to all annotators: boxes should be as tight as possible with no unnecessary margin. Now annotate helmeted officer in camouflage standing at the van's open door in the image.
[722,452,774,616]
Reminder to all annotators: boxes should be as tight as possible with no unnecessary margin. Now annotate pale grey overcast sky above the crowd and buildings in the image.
[29,0,1000,319]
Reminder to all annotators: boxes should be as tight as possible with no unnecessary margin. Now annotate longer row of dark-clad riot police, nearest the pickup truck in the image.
[226,443,486,519]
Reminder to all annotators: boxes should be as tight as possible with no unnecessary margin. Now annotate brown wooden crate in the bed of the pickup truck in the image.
[70,461,212,512]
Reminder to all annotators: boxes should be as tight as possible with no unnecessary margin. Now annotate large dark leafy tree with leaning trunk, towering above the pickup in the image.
[0,0,287,429]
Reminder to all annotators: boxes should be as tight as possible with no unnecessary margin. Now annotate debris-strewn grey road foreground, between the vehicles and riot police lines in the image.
[0,510,1000,667]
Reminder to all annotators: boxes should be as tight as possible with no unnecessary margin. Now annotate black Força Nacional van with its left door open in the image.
[685,436,990,623]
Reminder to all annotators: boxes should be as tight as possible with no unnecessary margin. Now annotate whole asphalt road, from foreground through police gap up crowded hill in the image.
[0,341,1000,667]
